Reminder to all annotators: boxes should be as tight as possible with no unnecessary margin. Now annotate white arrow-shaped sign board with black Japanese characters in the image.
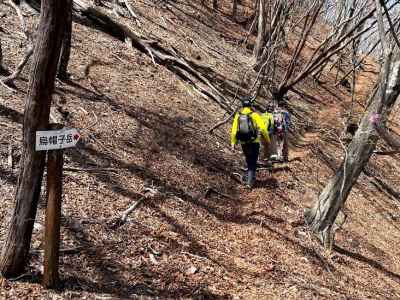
[36,128,81,151]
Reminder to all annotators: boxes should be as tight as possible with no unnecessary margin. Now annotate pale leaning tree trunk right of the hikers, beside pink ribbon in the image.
[305,54,400,247]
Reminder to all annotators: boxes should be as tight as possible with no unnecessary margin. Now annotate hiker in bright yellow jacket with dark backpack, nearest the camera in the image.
[231,98,270,188]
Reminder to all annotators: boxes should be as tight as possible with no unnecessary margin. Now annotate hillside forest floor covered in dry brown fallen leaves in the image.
[0,0,400,299]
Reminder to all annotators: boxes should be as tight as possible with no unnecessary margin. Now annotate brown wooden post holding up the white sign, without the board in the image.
[43,124,63,288]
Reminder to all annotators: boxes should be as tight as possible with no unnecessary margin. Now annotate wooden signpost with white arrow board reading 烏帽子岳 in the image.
[36,124,80,288]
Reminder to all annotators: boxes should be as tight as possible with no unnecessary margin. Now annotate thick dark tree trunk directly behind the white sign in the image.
[0,0,67,277]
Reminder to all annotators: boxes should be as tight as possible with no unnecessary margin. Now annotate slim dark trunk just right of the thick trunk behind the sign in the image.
[57,0,72,80]
